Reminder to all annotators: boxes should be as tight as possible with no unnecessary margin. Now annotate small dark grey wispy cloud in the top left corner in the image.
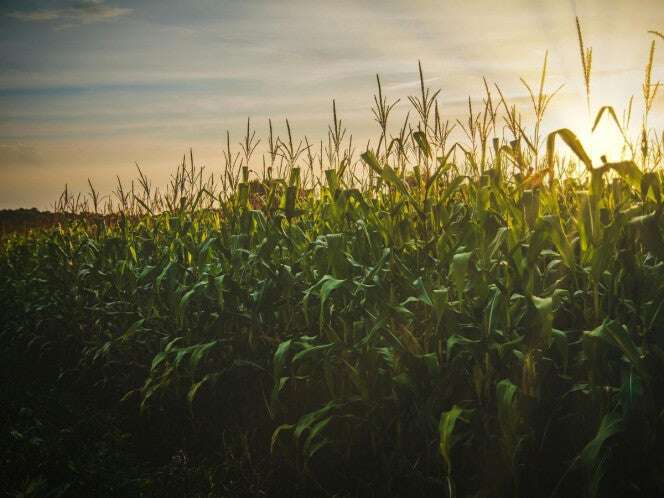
[7,0,133,29]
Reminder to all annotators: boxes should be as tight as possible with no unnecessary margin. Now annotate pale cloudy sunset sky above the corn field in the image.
[0,0,664,209]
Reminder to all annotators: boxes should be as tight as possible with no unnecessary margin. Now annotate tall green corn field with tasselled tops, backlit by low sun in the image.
[0,19,664,497]
